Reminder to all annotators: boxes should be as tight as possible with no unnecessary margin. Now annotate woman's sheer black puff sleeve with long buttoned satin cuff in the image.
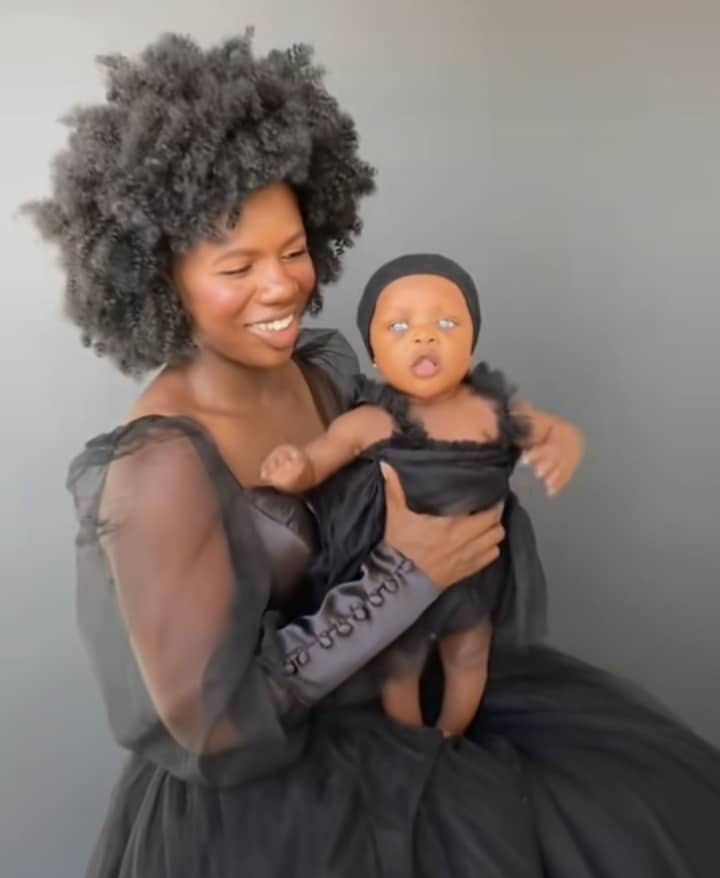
[71,425,438,784]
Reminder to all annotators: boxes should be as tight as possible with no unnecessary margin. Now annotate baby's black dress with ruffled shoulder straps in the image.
[308,363,546,696]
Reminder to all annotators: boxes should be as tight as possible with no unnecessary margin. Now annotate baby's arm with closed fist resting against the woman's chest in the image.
[260,405,393,494]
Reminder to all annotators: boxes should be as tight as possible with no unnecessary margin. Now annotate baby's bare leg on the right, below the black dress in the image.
[437,620,492,735]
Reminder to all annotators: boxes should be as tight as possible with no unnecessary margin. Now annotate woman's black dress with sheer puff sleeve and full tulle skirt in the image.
[69,331,720,878]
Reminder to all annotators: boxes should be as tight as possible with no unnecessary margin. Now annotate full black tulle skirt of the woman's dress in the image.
[83,647,720,878]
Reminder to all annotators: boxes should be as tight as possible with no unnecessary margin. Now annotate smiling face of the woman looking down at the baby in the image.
[174,184,315,368]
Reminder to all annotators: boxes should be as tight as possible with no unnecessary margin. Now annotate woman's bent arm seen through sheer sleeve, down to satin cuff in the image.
[95,430,440,755]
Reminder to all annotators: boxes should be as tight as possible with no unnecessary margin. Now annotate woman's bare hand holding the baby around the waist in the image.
[381,463,505,589]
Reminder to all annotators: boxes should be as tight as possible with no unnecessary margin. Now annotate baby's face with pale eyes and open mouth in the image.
[370,274,473,400]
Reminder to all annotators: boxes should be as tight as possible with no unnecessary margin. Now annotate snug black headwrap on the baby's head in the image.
[357,253,480,356]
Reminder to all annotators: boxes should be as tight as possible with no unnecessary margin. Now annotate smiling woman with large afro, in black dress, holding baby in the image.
[29,34,720,878]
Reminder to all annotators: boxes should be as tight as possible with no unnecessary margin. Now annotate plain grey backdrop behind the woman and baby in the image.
[0,0,720,878]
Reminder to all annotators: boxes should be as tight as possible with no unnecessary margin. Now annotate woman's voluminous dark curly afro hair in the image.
[23,28,375,375]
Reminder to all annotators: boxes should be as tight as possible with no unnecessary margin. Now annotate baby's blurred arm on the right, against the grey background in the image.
[513,401,585,496]
